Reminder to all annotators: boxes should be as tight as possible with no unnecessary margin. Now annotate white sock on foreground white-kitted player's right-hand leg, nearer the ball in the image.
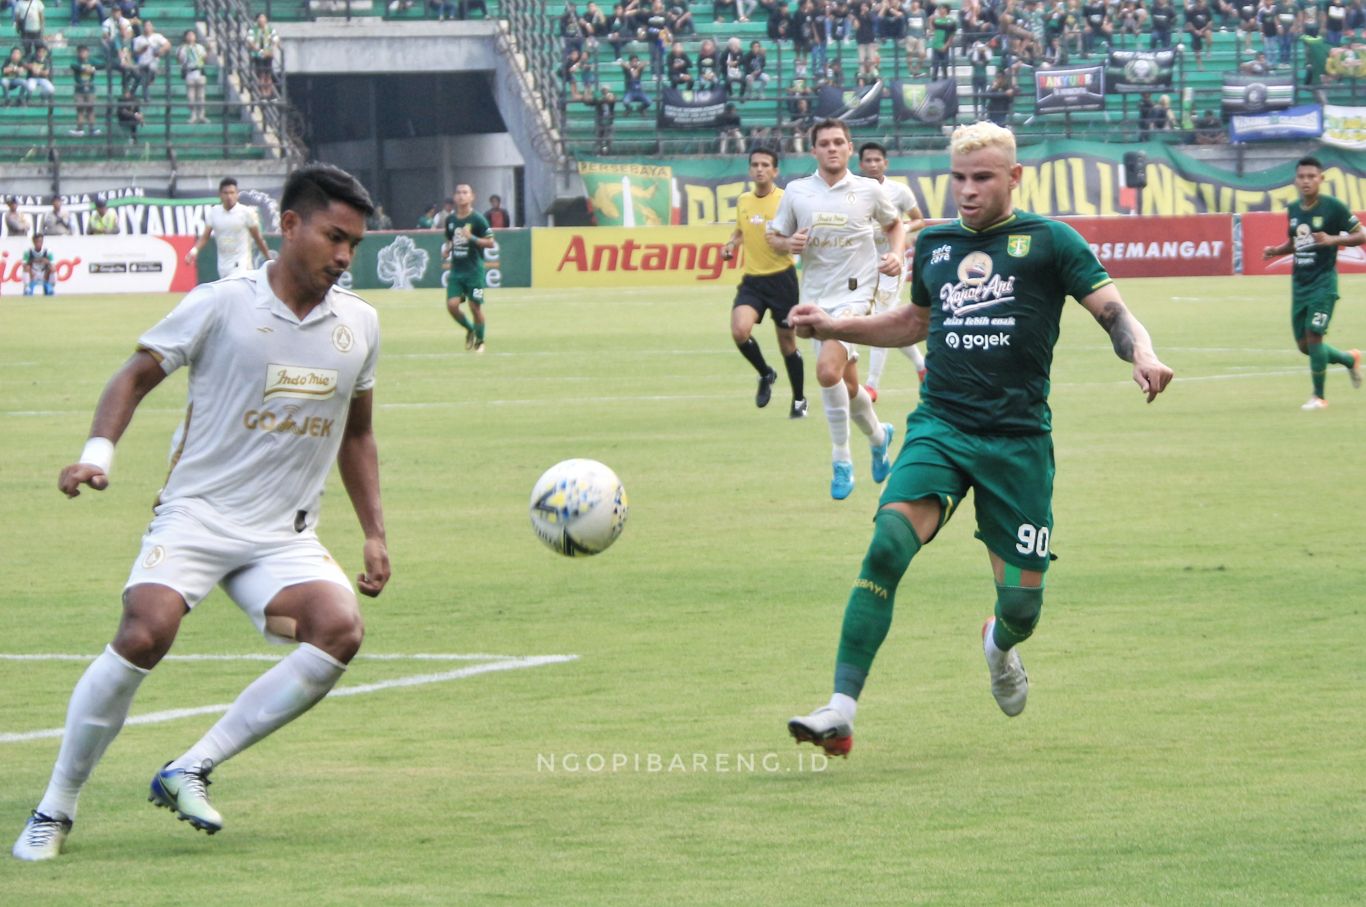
[168,642,346,769]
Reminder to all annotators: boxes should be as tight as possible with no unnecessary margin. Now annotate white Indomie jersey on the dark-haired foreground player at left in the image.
[138,265,380,535]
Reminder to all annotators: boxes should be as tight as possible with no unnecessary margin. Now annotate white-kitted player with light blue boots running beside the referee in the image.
[768,120,906,500]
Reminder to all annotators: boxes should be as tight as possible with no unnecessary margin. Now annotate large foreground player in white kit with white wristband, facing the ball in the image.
[12,164,389,861]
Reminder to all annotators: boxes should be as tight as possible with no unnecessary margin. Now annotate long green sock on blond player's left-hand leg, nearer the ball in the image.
[835,510,921,699]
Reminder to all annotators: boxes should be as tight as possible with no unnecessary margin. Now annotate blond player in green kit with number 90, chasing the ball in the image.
[788,123,1172,755]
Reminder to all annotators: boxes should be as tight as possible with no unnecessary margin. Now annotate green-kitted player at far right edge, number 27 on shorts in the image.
[1262,157,1366,410]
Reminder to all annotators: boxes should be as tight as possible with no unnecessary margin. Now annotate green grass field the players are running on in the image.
[0,277,1366,907]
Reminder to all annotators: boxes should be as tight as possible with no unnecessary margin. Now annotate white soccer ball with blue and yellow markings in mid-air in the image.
[531,459,628,557]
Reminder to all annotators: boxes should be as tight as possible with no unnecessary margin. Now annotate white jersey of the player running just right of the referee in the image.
[768,172,897,311]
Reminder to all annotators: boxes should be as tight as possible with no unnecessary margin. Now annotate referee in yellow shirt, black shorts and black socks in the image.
[721,148,806,419]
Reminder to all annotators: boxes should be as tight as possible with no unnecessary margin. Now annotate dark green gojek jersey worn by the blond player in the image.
[911,210,1111,434]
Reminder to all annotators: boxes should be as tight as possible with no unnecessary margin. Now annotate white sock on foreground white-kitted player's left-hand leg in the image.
[38,646,149,820]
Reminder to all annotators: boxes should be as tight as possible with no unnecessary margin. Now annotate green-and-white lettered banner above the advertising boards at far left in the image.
[0,187,280,236]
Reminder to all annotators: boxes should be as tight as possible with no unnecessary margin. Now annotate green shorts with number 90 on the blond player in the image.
[881,408,1055,572]
